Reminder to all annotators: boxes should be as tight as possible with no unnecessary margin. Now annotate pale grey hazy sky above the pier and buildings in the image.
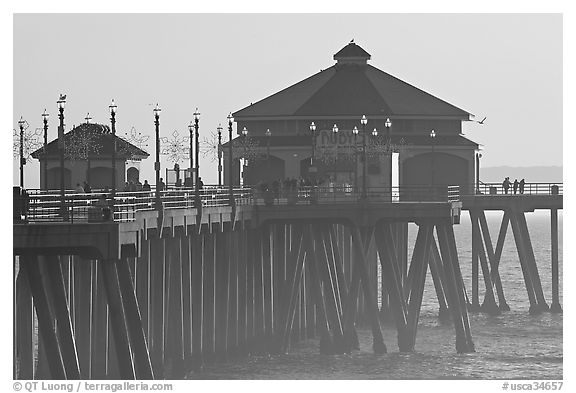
[12,14,563,187]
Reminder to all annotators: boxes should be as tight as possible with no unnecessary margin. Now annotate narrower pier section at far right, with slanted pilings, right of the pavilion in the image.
[462,183,563,314]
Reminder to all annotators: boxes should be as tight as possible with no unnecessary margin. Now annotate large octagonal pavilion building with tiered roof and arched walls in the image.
[223,42,479,191]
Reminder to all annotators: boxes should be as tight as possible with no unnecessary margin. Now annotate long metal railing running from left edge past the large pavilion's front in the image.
[14,185,460,223]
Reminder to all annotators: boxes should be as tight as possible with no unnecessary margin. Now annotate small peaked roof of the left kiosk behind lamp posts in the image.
[31,123,150,159]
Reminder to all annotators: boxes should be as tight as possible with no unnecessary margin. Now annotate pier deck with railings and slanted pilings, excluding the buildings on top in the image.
[14,187,562,379]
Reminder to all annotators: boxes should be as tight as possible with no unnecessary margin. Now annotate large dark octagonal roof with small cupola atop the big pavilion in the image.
[233,42,470,120]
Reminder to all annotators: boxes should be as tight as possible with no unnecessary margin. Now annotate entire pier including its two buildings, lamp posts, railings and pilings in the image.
[13,40,563,380]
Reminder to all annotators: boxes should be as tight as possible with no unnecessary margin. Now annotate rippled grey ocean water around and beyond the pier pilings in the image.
[187,212,563,380]
